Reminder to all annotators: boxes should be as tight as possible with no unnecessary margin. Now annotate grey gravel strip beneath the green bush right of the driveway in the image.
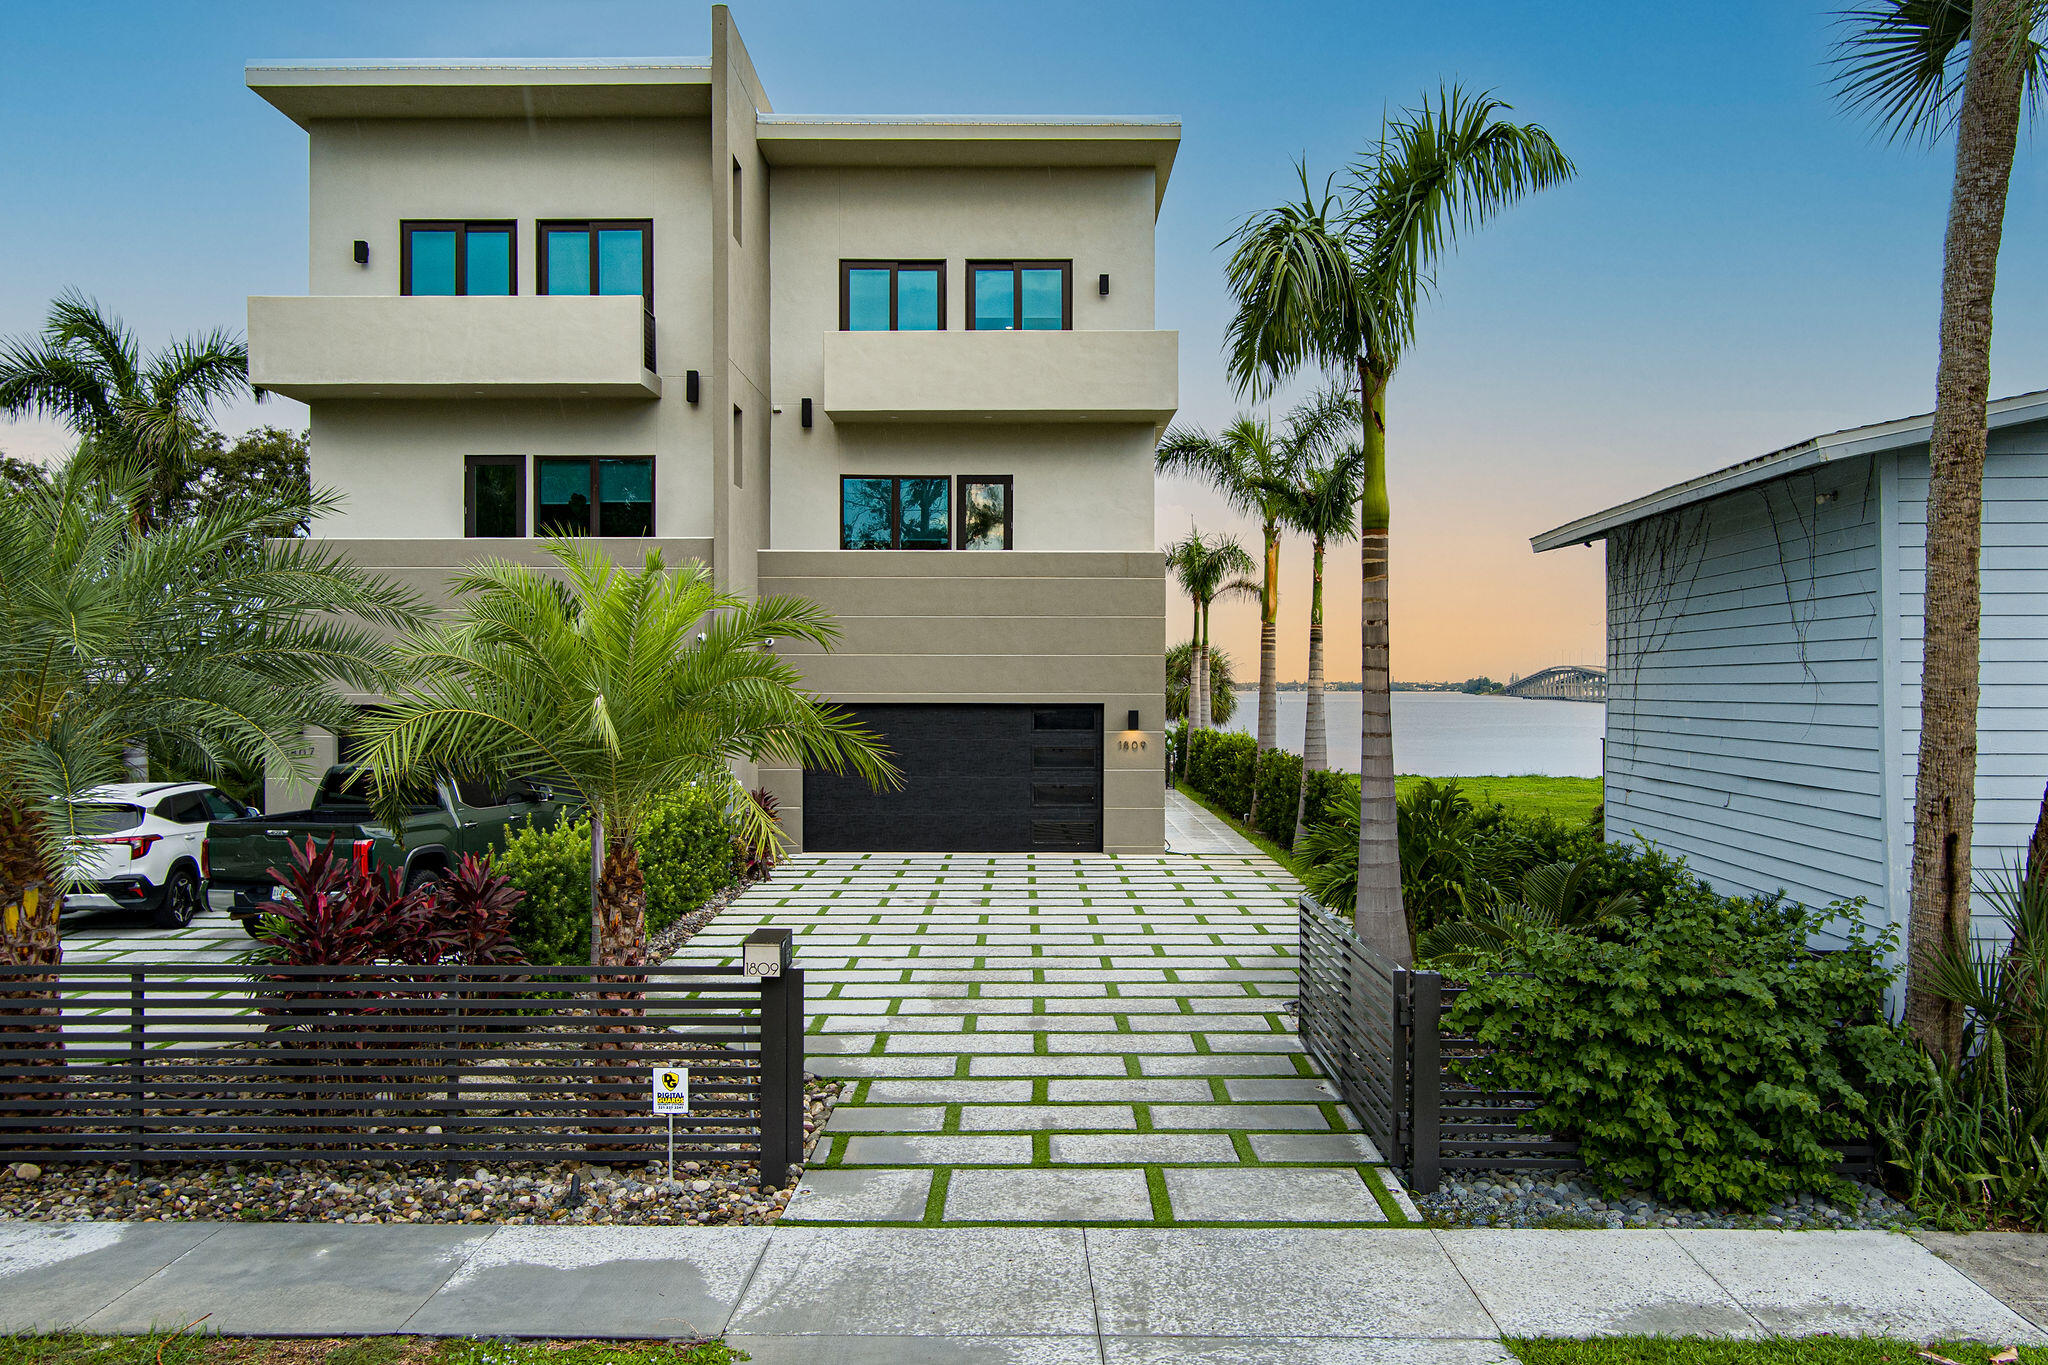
[1415,1171,1921,1232]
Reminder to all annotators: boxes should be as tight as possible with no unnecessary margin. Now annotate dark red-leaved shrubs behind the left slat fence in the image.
[244,839,526,966]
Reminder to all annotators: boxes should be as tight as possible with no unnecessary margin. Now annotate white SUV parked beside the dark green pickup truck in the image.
[66,782,252,929]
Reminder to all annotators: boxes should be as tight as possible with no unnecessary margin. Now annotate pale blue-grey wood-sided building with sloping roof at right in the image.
[1534,391,2048,949]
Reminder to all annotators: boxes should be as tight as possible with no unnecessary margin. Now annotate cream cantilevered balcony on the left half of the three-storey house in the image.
[250,295,662,401]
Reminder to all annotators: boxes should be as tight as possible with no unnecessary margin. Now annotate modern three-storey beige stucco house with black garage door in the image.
[248,6,1180,851]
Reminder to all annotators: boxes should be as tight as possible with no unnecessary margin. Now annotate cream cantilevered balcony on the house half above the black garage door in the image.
[823,332,1180,424]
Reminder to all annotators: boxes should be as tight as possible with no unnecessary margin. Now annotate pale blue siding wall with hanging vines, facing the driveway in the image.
[1606,458,1886,929]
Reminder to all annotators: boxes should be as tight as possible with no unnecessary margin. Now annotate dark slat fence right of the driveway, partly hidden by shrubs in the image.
[1298,896,1876,1193]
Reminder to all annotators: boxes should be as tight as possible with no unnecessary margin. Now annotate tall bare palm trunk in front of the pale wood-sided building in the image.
[1907,0,2030,1056]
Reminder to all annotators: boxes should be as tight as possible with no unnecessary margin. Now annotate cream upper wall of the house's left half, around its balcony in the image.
[292,119,717,538]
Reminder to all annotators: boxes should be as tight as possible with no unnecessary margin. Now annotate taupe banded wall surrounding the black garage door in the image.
[760,551,1165,853]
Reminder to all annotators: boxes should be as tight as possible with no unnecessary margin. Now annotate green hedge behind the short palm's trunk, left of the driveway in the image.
[498,786,739,962]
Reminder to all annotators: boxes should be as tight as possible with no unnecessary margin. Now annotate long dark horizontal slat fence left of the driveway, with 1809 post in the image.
[0,964,805,1185]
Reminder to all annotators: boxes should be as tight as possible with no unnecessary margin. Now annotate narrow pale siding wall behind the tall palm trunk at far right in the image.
[1886,422,2048,931]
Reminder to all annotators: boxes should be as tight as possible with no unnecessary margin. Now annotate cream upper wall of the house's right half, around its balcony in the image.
[770,166,1157,551]
